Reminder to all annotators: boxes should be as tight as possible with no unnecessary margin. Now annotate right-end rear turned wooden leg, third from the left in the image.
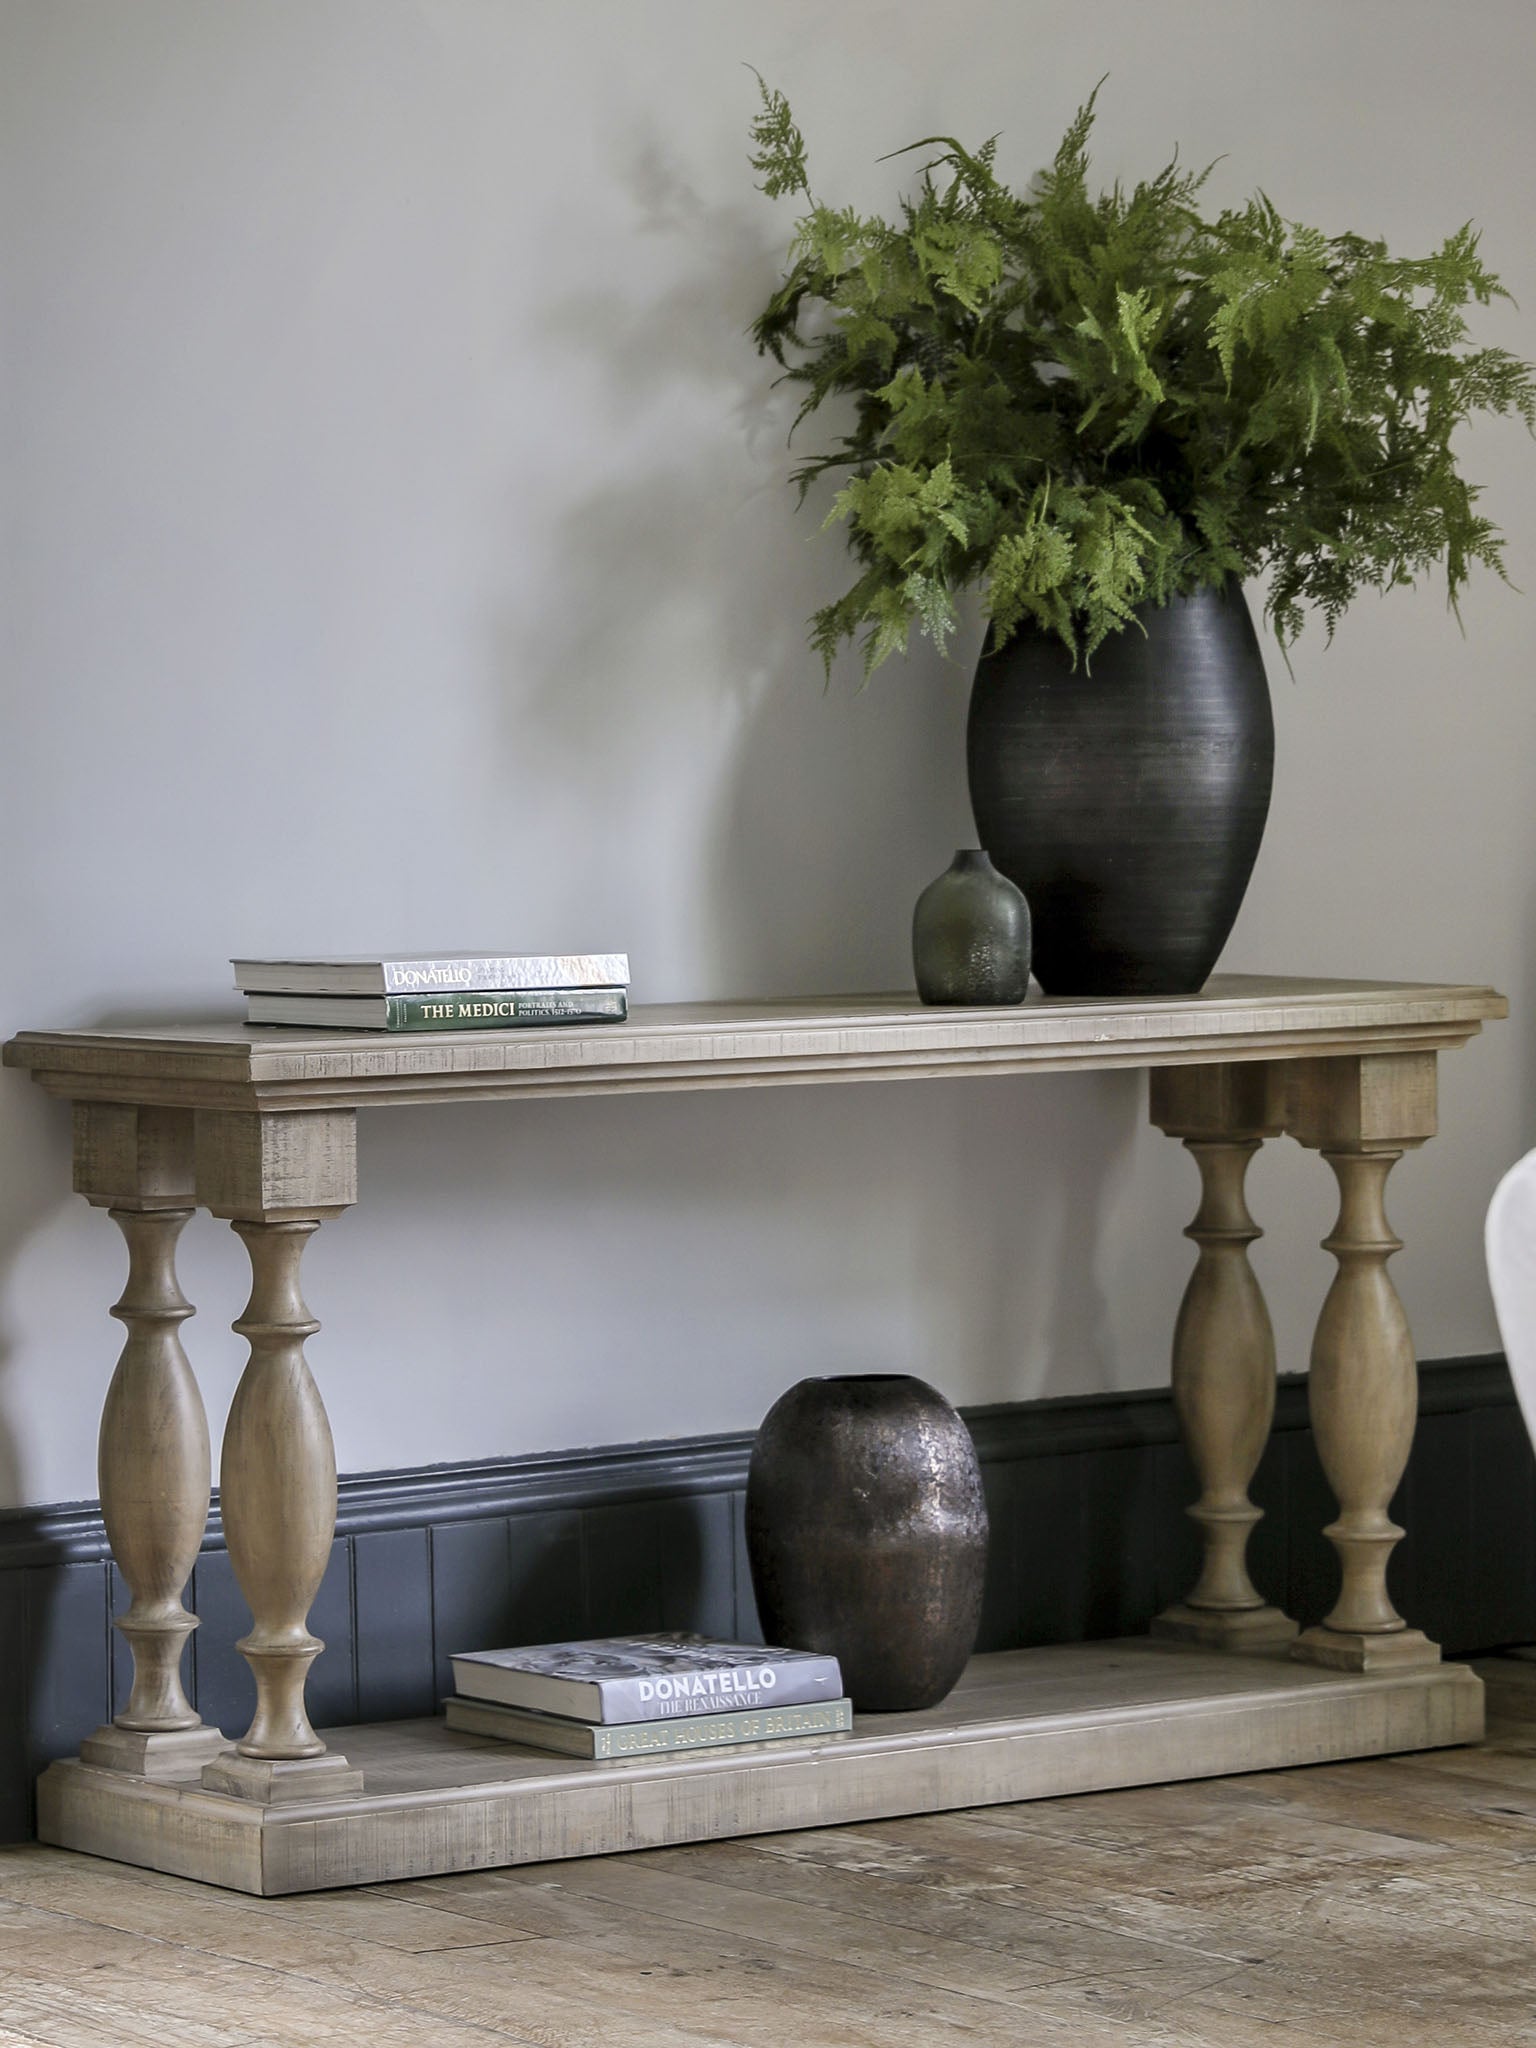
[1151,1063,1296,1651]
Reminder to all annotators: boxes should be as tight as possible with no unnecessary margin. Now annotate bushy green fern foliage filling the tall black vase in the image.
[752,80,1536,674]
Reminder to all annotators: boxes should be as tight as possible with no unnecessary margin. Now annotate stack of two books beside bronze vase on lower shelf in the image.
[442,1634,854,1757]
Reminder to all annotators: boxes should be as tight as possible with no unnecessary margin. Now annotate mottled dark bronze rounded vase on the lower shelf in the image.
[748,1374,987,1712]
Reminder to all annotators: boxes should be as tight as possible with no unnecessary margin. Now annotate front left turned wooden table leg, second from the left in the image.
[197,1112,362,1800]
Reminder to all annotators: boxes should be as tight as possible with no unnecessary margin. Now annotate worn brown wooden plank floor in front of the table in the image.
[0,1665,1536,2048]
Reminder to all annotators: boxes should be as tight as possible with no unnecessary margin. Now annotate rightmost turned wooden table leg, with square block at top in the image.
[1288,1053,1440,1671]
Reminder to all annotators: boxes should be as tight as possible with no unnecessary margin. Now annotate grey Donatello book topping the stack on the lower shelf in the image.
[451,1630,842,1726]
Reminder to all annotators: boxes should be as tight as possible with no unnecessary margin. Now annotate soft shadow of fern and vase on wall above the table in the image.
[496,119,973,995]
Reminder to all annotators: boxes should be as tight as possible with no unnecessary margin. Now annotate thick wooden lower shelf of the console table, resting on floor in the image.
[39,1638,1483,1894]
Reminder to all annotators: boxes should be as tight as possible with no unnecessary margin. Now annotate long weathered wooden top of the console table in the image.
[4,975,1509,1110]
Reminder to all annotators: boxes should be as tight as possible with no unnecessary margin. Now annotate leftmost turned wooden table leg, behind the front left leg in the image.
[76,1102,225,1778]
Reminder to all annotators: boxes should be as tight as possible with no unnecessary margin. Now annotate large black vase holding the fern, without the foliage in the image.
[967,582,1274,995]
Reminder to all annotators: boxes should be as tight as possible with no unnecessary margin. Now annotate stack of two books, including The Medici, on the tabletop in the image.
[229,952,629,1030]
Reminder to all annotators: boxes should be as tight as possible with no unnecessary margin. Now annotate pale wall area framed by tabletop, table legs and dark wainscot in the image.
[335,1073,1155,1474]
